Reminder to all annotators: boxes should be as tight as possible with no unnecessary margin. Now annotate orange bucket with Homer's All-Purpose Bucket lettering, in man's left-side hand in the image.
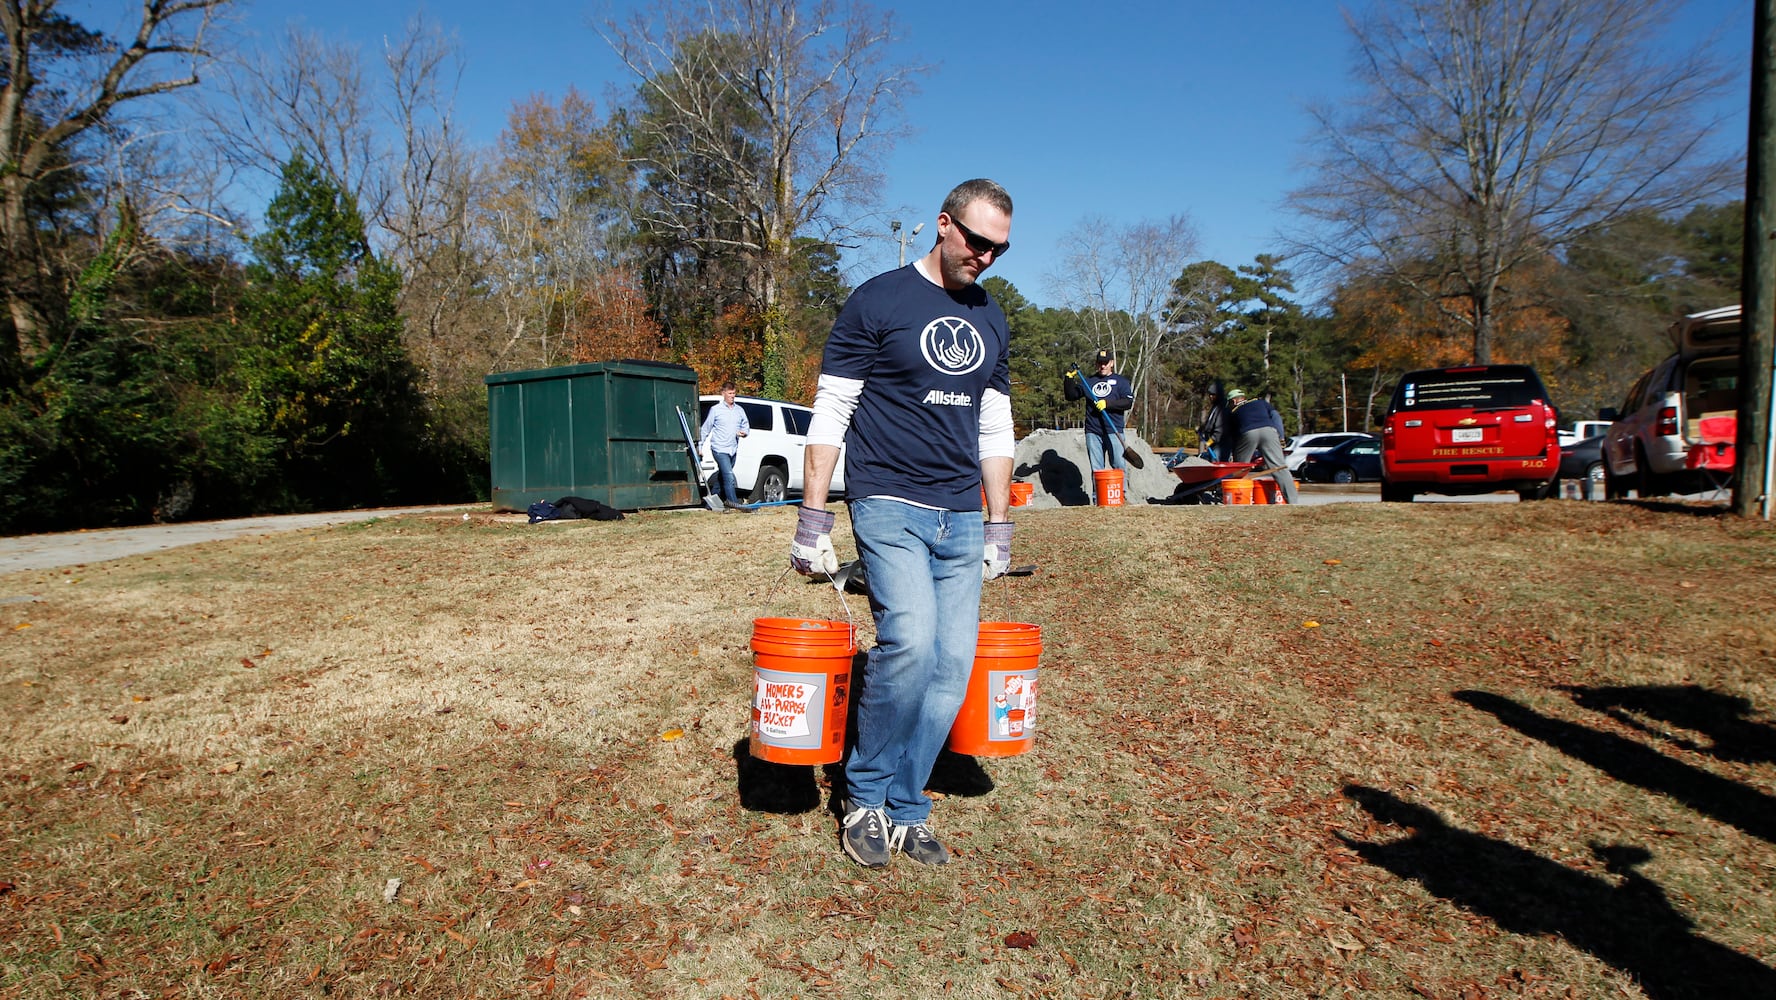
[748,618,858,764]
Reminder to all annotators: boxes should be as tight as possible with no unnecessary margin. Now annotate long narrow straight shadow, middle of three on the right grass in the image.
[1455,691,1776,849]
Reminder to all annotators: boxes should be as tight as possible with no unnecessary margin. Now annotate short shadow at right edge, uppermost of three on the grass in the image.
[1561,684,1776,764]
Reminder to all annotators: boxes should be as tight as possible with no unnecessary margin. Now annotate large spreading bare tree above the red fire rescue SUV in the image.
[1289,0,1739,362]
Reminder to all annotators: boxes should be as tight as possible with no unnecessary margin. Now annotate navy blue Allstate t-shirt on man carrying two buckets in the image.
[821,265,1011,510]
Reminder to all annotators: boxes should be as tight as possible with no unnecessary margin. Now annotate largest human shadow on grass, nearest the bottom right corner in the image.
[1337,785,1776,1000]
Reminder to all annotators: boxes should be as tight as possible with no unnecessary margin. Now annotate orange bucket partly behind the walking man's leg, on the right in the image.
[948,622,1043,757]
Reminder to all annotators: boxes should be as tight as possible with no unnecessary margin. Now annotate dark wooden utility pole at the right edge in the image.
[1733,0,1776,520]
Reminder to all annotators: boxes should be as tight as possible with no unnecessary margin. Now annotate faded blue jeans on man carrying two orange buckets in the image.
[845,499,984,826]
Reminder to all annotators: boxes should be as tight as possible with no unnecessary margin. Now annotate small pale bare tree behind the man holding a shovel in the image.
[1048,215,1197,426]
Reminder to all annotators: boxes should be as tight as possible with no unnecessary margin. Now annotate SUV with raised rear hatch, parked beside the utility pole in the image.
[1602,306,1739,497]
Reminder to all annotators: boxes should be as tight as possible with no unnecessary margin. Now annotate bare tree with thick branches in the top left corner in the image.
[0,0,229,387]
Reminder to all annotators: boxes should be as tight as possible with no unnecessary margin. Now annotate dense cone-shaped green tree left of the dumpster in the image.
[243,153,426,506]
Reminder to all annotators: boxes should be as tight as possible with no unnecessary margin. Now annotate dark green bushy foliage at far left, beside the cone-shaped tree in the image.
[0,215,274,531]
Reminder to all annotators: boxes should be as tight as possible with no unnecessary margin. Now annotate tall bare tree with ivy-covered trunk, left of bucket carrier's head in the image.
[604,0,922,393]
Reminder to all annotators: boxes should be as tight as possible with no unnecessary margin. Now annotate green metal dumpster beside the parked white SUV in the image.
[485,361,698,510]
